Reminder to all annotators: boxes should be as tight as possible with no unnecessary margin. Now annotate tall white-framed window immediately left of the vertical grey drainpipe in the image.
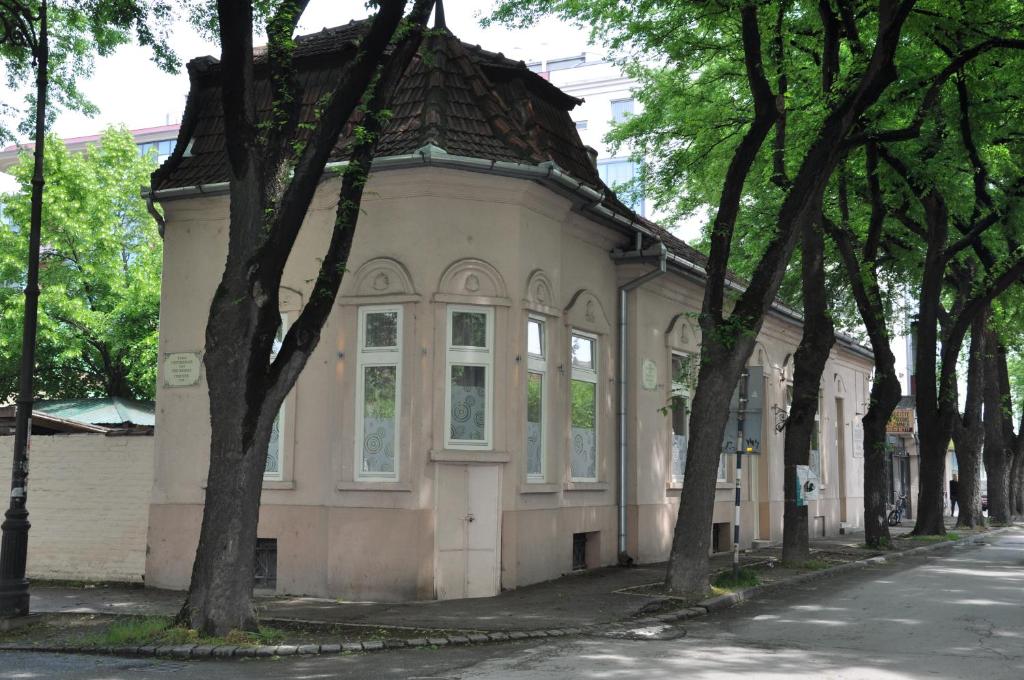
[569,330,599,481]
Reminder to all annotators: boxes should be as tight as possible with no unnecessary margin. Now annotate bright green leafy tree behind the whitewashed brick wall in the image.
[0,129,162,401]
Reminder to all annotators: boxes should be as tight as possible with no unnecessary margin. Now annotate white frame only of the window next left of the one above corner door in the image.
[352,304,404,482]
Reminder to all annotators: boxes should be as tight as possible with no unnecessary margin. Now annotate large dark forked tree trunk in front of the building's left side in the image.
[179,0,433,635]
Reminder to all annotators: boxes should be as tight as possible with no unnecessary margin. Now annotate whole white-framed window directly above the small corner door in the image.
[444,304,495,450]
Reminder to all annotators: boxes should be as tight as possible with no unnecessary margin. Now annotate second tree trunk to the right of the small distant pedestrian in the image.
[984,323,1011,524]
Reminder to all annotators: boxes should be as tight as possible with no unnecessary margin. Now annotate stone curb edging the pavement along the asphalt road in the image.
[6,526,1017,660]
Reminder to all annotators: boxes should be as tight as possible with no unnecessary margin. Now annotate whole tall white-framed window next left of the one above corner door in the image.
[355,306,401,481]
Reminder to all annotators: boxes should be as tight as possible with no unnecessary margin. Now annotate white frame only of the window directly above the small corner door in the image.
[444,304,495,451]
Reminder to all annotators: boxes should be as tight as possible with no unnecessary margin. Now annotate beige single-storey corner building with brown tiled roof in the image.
[146,11,871,600]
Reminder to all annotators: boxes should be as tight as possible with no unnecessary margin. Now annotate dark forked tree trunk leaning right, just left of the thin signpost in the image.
[666,1,910,595]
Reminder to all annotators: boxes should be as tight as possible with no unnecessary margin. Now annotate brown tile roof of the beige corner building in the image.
[153,22,706,266]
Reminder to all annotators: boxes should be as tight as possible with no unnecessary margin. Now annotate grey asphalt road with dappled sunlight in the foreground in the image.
[0,532,1024,680]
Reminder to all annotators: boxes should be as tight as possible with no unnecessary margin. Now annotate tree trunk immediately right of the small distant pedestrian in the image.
[950,320,986,528]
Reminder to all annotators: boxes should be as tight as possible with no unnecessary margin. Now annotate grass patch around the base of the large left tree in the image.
[82,617,285,647]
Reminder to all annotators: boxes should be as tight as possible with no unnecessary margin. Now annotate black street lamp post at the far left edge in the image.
[0,0,49,618]
